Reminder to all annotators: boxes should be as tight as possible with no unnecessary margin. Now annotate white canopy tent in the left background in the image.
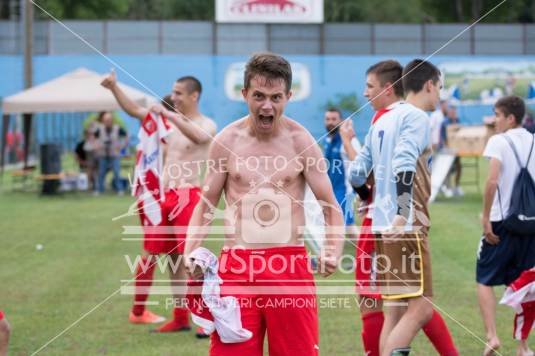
[0,68,156,170]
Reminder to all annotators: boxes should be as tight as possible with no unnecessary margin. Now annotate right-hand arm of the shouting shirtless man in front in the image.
[303,133,345,277]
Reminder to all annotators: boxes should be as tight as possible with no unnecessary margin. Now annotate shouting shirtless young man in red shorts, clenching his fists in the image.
[184,53,344,356]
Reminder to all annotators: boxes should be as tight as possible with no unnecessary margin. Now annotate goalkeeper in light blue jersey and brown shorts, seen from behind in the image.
[349,60,441,356]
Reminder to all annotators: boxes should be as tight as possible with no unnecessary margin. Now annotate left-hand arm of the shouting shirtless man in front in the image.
[184,136,228,263]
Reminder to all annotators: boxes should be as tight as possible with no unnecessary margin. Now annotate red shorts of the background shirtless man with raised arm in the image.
[138,187,201,254]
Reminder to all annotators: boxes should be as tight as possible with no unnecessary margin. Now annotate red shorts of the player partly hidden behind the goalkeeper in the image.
[355,216,381,299]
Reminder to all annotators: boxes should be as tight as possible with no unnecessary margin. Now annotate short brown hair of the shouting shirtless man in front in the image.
[243,53,292,93]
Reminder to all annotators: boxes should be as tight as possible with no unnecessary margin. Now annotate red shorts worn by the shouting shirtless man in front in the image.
[210,246,319,356]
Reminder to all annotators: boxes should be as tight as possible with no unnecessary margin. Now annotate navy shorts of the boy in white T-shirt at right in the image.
[476,221,535,286]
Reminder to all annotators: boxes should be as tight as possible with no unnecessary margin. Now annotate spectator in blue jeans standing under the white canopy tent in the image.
[94,111,128,195]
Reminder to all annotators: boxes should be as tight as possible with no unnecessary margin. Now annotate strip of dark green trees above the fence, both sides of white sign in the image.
[19,0,535,23]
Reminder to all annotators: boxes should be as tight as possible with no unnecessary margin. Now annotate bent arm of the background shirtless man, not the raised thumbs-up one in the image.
[151,105,216,144]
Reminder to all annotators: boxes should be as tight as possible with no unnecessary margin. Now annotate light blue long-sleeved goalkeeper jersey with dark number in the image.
[349,102,430,233]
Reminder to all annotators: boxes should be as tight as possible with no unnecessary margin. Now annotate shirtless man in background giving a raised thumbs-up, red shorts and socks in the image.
[102,72,216,332]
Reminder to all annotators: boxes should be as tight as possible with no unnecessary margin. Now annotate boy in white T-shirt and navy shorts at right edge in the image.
[476,96,535,355]
